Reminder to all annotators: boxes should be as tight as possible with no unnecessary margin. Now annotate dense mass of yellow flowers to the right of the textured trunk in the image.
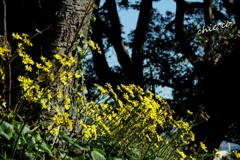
[80,83,195,156]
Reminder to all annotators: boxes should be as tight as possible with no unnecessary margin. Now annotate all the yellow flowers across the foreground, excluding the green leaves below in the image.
[0,33,212,160]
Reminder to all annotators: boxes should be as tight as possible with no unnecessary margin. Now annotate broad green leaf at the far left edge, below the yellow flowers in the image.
[0,120,15,140]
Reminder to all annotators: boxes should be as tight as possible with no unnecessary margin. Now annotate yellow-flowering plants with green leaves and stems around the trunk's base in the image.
[0,33,221,160]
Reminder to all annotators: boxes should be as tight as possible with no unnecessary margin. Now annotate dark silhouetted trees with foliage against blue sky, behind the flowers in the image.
[84,0,239,155]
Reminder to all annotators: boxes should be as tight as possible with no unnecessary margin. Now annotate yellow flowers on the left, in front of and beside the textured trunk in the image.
[6,33,77,137]
